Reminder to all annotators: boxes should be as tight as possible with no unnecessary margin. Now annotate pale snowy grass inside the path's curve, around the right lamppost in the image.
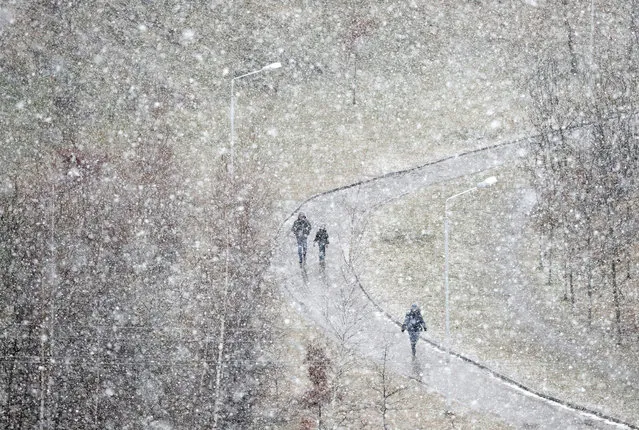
[358,167,639,422]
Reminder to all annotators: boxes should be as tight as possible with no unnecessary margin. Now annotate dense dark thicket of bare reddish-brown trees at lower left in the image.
[0,145,288,429]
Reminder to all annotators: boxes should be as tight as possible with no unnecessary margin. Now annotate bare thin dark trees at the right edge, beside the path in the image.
[527,57,639,342]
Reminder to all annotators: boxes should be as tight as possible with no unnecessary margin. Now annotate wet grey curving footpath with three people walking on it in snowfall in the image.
[272,141,637,429]
